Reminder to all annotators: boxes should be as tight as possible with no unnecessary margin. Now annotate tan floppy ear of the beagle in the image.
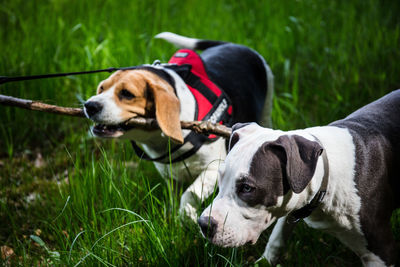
[146,75,183,144]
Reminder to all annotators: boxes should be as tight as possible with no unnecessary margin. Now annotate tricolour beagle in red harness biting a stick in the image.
[84,32,273,220]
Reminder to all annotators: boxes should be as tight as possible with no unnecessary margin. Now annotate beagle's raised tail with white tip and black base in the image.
[154,32,226,50]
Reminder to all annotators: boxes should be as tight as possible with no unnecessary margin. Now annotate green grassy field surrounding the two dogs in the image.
[0,0,400,266]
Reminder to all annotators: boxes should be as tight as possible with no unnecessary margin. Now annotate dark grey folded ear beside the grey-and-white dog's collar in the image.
[267,135,323,194]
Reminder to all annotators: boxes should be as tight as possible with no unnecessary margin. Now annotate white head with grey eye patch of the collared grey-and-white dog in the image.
[199,123,322,247]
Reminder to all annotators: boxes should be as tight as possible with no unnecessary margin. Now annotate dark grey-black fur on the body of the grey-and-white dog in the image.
[330,90,400,265]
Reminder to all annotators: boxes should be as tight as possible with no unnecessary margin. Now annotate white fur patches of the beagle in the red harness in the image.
[89,32,273,225]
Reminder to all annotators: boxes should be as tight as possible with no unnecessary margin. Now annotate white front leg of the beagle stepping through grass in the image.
[179,161,219,222]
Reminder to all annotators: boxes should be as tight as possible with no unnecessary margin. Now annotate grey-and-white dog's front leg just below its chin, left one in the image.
[262,216,296,266]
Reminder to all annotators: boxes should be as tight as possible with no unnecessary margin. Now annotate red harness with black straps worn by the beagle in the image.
[132,49,233,163]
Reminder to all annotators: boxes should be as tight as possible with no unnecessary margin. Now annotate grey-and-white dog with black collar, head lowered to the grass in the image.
[199,89,400,266]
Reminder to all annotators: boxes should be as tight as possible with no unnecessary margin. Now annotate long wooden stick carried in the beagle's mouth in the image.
[0,95,232,138]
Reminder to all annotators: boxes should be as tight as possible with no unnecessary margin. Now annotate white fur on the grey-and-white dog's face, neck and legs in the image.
[202,124,383,266]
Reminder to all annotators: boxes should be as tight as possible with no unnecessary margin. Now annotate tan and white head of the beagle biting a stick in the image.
[84,69,183,143]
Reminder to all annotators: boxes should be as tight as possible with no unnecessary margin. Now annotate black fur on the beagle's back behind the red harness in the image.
[200,43,270,123]
